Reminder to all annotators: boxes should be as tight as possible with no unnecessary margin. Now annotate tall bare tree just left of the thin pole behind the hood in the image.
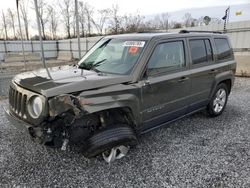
[59,0,73,38]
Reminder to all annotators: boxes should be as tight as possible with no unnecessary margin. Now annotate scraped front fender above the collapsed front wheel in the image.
[78,84,141,123]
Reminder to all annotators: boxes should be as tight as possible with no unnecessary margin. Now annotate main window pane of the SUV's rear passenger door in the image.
[190,40,208,64]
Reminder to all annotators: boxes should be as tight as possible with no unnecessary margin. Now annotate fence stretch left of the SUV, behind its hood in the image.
[0,37,101,98]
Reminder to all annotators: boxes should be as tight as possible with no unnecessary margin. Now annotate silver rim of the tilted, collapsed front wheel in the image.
[102,146,129,163]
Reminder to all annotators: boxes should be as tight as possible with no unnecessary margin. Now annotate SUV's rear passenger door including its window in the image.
[188,37,215,112]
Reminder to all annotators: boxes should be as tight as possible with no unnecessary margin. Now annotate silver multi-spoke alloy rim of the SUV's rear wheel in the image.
[213,88,227,113]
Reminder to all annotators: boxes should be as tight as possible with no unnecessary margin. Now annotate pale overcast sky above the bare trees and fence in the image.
[0,0,250,35]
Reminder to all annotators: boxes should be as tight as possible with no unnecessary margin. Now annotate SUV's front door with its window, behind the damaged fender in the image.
[141,39,190,131]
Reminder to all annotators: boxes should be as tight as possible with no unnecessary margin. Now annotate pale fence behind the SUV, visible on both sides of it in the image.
[0,21,250,96]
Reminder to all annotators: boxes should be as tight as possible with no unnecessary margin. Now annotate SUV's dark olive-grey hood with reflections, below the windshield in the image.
[13,65,132,97]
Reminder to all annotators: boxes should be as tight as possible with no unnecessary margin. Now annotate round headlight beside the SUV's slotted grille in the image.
[28,96,43,119]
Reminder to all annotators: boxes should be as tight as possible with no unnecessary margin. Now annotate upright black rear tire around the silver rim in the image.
[207,83,229,117]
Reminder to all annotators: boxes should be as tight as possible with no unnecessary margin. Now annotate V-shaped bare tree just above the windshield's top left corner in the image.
[92,8,111,34]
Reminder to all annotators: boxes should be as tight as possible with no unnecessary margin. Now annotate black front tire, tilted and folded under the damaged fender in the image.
[83,124,137,158]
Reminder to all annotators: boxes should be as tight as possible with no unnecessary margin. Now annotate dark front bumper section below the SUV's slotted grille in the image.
[3,108,32,132]
